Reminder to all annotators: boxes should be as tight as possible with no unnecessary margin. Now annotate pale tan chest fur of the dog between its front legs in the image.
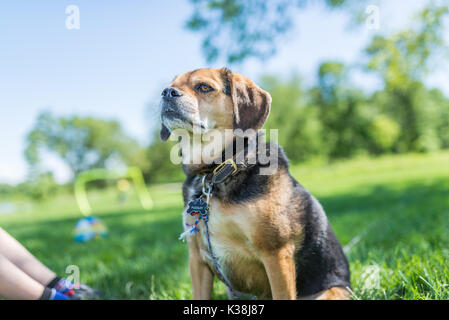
[183,198,269,296]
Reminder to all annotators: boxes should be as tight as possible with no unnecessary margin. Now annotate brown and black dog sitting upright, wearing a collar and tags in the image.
[161,68,350,299]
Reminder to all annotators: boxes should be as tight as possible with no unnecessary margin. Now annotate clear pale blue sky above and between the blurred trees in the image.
[0,0,449,183]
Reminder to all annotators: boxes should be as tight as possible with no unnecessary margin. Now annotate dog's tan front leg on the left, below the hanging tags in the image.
[188,238,214,300]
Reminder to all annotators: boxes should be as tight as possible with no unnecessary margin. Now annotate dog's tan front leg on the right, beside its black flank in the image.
[262,244,296,300]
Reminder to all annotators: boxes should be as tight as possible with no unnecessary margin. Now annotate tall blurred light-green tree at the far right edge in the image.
[366,5,448,152]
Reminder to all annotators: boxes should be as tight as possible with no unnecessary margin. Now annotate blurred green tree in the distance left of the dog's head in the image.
[25,112,139,176]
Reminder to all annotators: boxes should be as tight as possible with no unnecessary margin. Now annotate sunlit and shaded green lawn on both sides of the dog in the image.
[0,152,449,299]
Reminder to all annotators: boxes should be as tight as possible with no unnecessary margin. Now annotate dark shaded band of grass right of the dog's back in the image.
[318,179,449,260]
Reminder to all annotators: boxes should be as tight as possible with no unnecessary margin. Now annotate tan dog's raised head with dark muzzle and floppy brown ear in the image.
[161,68,271,141]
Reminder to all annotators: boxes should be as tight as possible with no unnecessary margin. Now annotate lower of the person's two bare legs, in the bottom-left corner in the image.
[0,255,45,300]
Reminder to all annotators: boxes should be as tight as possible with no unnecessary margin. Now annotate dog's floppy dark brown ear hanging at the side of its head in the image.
[221,68,271,131]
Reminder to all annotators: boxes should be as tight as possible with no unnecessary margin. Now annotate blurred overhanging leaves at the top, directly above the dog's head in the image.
[187,0,347,63]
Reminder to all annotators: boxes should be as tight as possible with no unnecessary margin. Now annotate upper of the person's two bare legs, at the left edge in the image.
[0,228,56,284]
